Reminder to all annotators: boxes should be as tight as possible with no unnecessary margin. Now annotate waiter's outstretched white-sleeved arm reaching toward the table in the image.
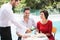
[4,9,28,30]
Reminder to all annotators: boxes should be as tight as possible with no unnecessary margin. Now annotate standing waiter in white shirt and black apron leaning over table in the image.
[0,0,27,40]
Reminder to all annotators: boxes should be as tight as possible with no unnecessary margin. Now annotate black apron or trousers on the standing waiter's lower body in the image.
[0,26,12,40]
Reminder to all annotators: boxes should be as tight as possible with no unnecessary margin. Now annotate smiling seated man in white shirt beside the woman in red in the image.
[17,7,36,40]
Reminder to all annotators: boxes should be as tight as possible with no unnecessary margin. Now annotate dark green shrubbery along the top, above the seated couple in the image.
[25,0,60,9]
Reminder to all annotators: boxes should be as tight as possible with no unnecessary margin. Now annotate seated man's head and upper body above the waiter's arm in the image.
[21,7,36,29]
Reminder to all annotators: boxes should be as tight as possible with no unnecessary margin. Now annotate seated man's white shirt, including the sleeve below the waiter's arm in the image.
[17,18,36,35]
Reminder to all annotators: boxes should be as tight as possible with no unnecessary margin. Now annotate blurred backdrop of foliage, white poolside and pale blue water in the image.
[0,0,60,40]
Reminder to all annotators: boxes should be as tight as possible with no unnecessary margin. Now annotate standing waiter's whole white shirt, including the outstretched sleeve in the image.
[0,3,27,33]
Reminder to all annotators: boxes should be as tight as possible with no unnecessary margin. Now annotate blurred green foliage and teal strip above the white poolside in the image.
[0,0,60,15]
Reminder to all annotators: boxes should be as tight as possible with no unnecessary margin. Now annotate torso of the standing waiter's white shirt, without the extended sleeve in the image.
[0,3,13,27]
